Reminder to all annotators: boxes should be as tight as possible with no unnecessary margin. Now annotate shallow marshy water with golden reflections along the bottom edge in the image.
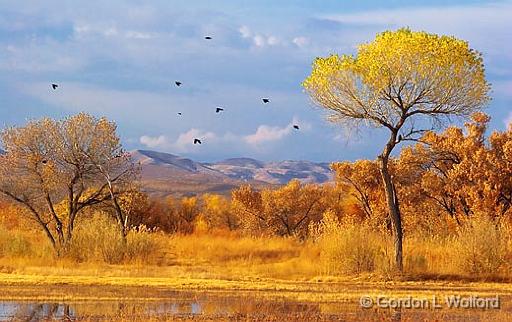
[0,292,512,321]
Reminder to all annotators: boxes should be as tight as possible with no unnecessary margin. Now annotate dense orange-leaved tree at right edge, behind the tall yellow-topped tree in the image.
[399,113,512,225]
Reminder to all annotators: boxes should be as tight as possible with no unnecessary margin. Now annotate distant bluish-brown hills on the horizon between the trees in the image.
[131,150,333,196]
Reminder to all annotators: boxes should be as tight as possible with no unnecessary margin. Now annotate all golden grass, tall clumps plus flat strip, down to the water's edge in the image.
[0,215,512,320]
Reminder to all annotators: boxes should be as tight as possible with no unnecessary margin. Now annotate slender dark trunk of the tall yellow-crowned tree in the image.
[379,155,403,272]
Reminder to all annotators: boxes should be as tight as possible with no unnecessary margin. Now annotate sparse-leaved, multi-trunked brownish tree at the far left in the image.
[0,113,137,254]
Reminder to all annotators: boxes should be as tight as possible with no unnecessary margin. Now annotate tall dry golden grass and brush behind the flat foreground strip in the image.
[0,215,512,281]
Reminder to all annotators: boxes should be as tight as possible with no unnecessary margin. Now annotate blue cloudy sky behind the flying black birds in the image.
[0,0,512,161]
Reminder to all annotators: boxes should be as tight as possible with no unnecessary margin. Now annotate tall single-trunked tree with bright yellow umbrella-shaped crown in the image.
[303,29,489,271]
